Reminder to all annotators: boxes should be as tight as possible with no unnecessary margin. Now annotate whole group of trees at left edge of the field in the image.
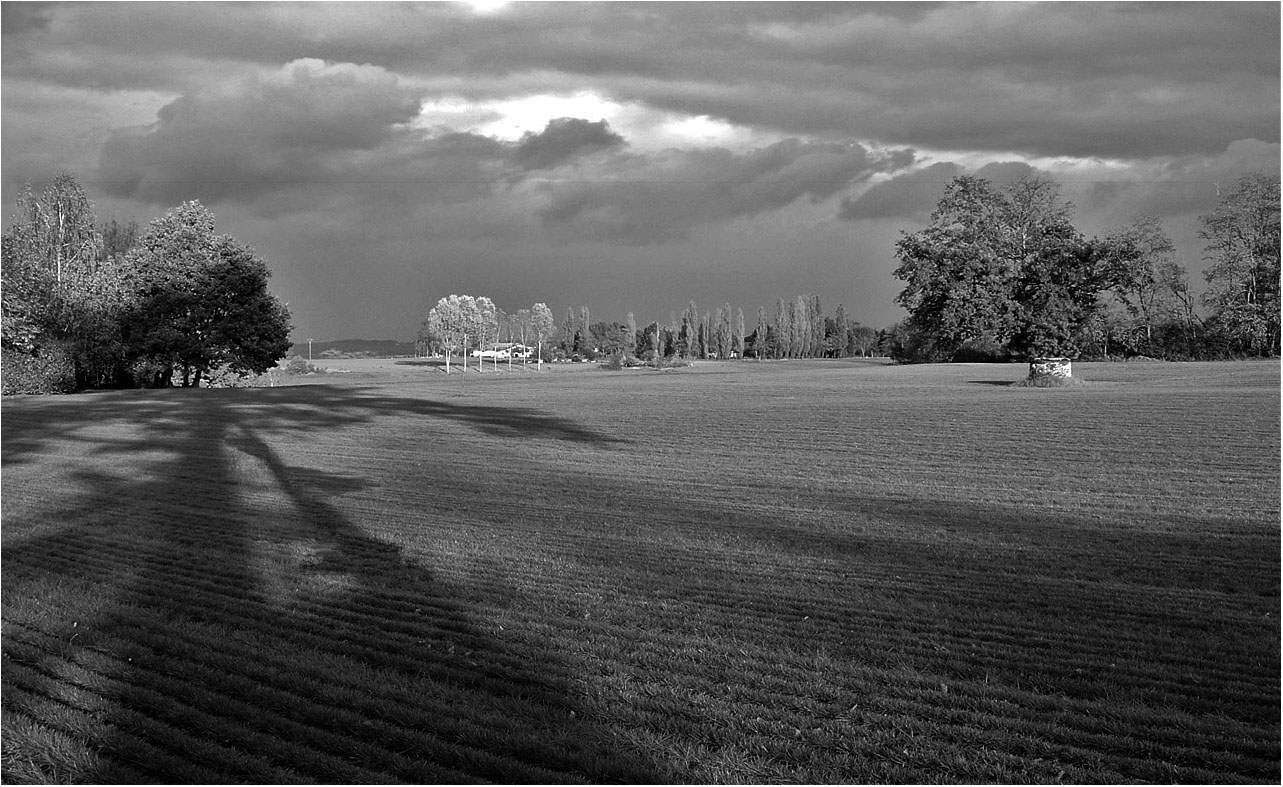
[0,173,290,393]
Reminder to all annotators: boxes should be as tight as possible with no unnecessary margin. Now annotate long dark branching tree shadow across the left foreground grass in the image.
[3,386,654,783]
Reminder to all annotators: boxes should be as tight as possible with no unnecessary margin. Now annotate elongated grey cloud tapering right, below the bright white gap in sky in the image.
[539,139,913,244]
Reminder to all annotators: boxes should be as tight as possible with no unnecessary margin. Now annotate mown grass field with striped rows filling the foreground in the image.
[0,361,1280,783]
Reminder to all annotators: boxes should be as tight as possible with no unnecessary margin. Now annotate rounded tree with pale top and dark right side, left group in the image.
[124,202,290,386]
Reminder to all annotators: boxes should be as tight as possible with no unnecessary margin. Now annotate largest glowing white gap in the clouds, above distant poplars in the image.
[416,90,781,151]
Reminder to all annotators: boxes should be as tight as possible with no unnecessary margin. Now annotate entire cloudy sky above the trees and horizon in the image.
[0,0,1280,340]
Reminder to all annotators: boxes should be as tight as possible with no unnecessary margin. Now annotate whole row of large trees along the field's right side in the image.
[887,175,1279,361]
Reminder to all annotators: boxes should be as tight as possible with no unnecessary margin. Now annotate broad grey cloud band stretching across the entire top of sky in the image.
[3,3,1279,157]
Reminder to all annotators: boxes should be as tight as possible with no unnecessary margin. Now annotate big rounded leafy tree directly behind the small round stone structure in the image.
[896,176,1106,361]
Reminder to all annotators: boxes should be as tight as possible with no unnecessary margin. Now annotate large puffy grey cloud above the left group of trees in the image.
[96,60,504,204]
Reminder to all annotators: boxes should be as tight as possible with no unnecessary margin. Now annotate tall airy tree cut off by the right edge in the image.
[1200,172,1279,354]
